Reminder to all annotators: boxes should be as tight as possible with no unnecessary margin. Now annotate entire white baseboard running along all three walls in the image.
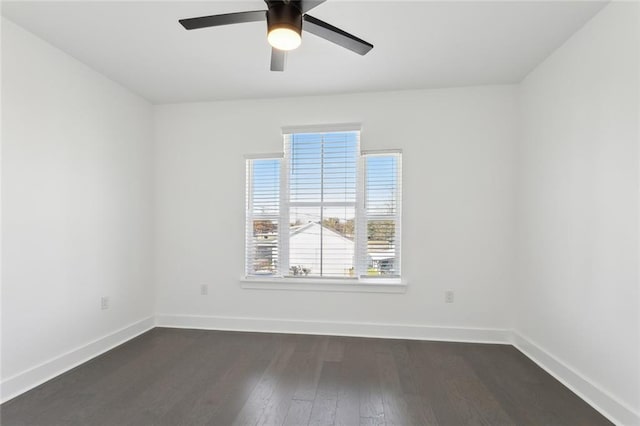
[0,314,640,426]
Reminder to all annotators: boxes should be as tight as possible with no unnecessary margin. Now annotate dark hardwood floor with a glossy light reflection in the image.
[0,328,610,426]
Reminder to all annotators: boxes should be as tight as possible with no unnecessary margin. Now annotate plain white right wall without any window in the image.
[515,3,640,424]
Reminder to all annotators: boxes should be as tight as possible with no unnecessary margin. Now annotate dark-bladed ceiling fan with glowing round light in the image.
[178,0,373,71]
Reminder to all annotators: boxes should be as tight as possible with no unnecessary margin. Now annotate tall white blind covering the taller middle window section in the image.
[285,132,359,278]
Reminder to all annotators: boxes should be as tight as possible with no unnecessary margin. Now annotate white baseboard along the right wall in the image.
[512,331,640,426]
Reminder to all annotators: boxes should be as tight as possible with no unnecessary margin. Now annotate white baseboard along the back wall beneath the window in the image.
[156,314,511,344]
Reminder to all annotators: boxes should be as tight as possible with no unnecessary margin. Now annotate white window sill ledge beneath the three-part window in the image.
[240,277,407,293]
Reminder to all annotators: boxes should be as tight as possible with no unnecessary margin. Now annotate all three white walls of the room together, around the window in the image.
[2,3,640,423]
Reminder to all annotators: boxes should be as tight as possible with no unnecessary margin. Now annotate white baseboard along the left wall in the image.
[0,317,155,402]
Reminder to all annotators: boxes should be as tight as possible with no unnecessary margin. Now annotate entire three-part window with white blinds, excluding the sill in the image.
[246,125,401,282]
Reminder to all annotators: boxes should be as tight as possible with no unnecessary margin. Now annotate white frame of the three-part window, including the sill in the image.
[240,123,407,293]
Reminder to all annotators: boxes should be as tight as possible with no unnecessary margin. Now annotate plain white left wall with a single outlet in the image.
[2,19,153,398]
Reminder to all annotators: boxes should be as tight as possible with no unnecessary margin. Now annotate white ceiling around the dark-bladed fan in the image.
[2,0,605,103]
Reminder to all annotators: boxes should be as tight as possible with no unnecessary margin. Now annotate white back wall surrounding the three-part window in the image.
[155,86,517,329]
